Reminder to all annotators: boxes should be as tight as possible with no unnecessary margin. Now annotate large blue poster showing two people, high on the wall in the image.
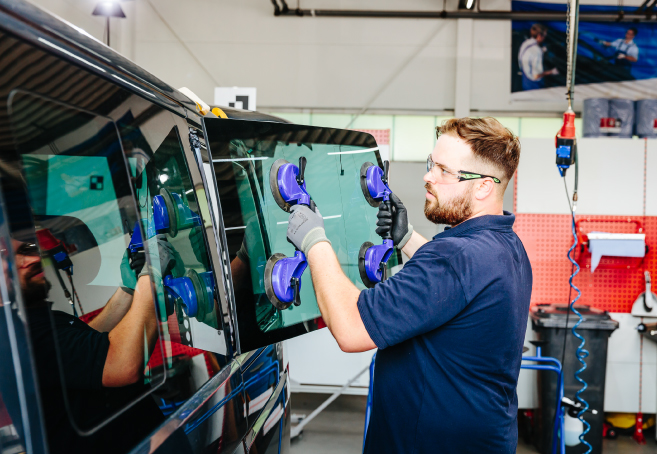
[511,1,657,101]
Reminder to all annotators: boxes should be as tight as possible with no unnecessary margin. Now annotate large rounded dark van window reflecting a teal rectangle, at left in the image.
[10,92,177,432]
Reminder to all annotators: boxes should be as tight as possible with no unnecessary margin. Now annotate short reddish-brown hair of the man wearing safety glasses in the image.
[436,117,520,186]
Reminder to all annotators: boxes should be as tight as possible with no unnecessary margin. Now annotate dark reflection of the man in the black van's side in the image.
[12,232,187,453]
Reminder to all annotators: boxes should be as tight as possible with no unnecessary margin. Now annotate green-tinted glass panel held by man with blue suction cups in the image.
[206,120,401,345]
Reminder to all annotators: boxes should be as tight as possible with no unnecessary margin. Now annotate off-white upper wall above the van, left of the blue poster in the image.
[24,0,641,114]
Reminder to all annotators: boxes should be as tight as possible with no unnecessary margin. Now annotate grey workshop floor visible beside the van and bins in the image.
[291,393,657,454]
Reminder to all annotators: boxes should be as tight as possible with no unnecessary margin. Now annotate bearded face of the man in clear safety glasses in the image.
[424,134,476,226]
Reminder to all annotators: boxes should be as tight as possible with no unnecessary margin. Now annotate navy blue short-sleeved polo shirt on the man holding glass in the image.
[358,212,532,454]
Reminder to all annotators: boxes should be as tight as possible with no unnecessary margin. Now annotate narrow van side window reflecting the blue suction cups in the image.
[119,112,226,354]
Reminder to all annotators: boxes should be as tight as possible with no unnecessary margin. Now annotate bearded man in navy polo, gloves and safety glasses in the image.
[287,118,532,454]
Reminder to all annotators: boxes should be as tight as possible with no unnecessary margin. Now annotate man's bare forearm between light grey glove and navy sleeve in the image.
[307,242,376,352]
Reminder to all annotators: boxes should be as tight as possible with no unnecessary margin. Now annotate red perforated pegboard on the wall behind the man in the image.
[514,213,657,312]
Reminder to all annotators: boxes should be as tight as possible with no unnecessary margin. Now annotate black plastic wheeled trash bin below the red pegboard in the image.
[531,304,618,454]
